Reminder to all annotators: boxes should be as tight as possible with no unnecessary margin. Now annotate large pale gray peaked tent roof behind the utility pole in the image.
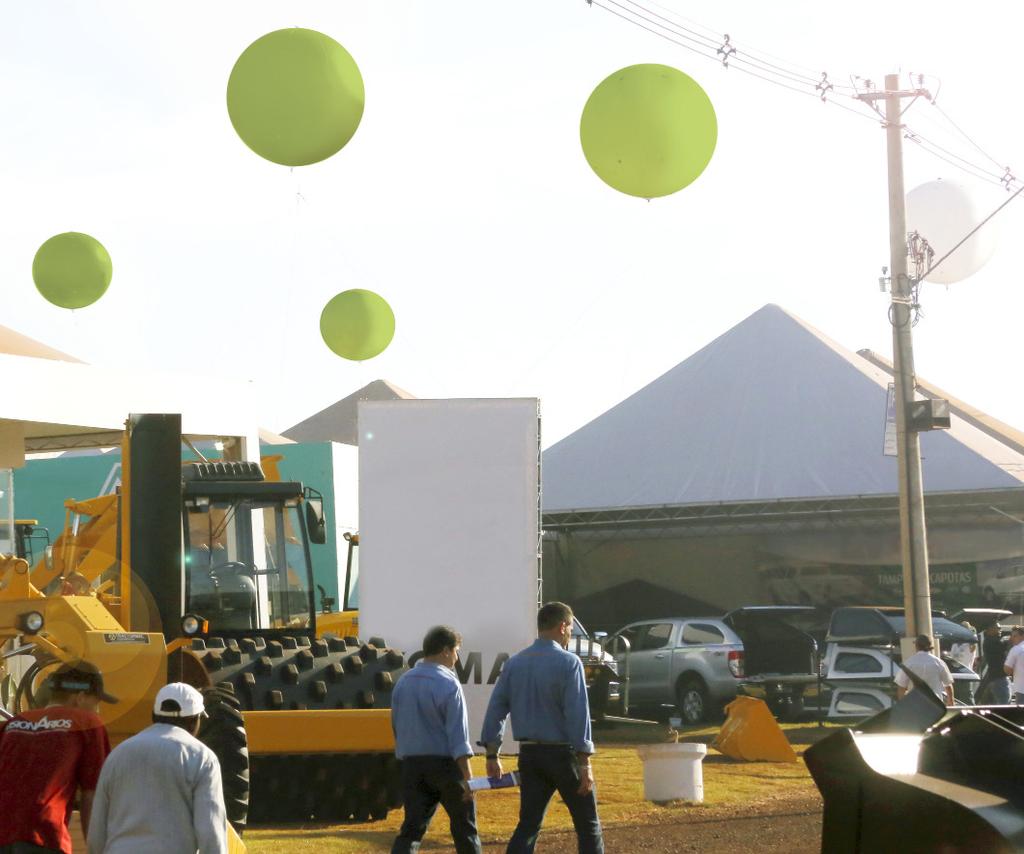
[544,305,1024,513]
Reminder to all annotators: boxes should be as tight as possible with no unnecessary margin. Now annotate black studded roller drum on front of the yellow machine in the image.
[193,636,406,823]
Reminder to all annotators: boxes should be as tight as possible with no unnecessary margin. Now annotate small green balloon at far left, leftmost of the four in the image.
[32,231,114,308]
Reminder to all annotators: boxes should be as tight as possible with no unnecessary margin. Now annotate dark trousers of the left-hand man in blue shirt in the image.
[391,756,480,854]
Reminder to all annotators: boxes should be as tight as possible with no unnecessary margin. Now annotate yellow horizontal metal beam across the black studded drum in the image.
[243,709,394,754]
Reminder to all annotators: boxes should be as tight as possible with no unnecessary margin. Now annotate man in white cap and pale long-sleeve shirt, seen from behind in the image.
[89,682,227,854]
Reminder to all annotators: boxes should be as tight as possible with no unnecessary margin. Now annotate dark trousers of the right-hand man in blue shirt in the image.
[506,744,604,854]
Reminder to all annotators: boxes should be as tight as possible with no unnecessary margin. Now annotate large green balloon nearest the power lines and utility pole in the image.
[580,65,718,199]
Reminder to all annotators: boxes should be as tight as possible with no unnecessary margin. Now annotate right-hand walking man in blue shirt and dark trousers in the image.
[480,602,604,854]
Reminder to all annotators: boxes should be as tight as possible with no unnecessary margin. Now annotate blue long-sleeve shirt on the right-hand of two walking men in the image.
[480,638,594,754]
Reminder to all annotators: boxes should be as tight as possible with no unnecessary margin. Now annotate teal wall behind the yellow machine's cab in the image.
[14,442,345,606]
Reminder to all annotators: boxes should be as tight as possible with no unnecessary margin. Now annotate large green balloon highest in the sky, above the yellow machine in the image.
[227,28,366,166]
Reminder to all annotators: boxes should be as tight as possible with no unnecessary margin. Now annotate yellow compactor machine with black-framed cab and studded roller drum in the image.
[0,415,406,828]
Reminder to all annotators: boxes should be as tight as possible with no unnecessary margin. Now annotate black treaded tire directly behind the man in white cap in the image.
[199,688,249,835]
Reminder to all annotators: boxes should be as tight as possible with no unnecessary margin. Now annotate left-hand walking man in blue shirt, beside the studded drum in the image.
[391,626,480,854]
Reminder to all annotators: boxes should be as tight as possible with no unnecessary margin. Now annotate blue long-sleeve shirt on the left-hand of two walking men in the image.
[391,660,473,759]
